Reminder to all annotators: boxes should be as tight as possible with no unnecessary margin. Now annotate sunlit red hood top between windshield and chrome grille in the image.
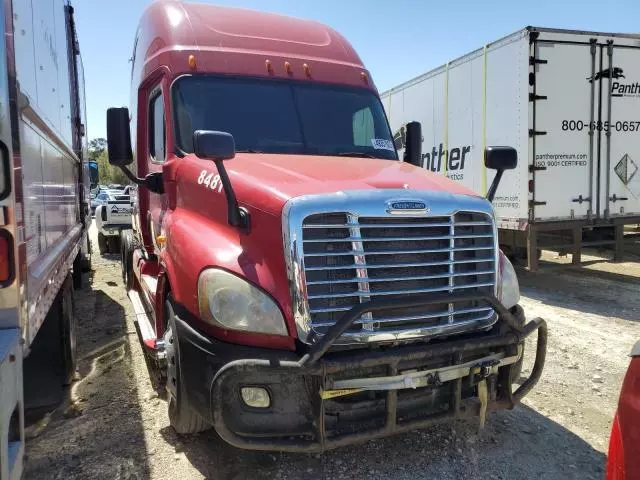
[215,153,477,215]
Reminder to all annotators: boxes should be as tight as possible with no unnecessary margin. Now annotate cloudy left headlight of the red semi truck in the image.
[198,269,287,335]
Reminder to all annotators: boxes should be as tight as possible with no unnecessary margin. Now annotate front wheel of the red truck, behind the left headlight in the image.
[164,300,211,434]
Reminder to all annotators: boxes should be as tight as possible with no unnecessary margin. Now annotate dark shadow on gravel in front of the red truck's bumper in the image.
[160,405,605,480]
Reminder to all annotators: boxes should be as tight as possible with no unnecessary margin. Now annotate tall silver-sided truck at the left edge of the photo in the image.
[0,0,97,480]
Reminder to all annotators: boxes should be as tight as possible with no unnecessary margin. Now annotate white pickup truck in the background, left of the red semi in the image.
[96,192,132,255]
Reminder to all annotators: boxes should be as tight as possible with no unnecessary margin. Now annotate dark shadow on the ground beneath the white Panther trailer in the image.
[517,264,640,322]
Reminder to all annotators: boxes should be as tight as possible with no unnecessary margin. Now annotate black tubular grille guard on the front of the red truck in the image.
[211,295,547,452]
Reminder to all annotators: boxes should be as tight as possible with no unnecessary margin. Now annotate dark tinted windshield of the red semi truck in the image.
[173,76,398,160]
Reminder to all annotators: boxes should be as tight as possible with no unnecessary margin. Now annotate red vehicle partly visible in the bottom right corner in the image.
[607,341,640,480]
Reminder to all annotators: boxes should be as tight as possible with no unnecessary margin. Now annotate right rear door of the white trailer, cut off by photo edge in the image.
[600,44,640,217]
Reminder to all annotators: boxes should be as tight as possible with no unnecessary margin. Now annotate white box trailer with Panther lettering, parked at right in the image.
[381,27,640,270]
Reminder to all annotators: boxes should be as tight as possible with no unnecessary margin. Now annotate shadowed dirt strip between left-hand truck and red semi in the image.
[24,273,150,479]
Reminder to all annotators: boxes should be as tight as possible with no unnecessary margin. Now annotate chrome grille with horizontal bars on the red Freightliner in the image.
[301,212,496,340]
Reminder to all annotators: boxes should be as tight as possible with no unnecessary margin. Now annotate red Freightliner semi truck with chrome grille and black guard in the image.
[107,1,546,451]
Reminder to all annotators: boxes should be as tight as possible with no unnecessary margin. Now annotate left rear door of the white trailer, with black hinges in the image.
[529,39,598,220]
